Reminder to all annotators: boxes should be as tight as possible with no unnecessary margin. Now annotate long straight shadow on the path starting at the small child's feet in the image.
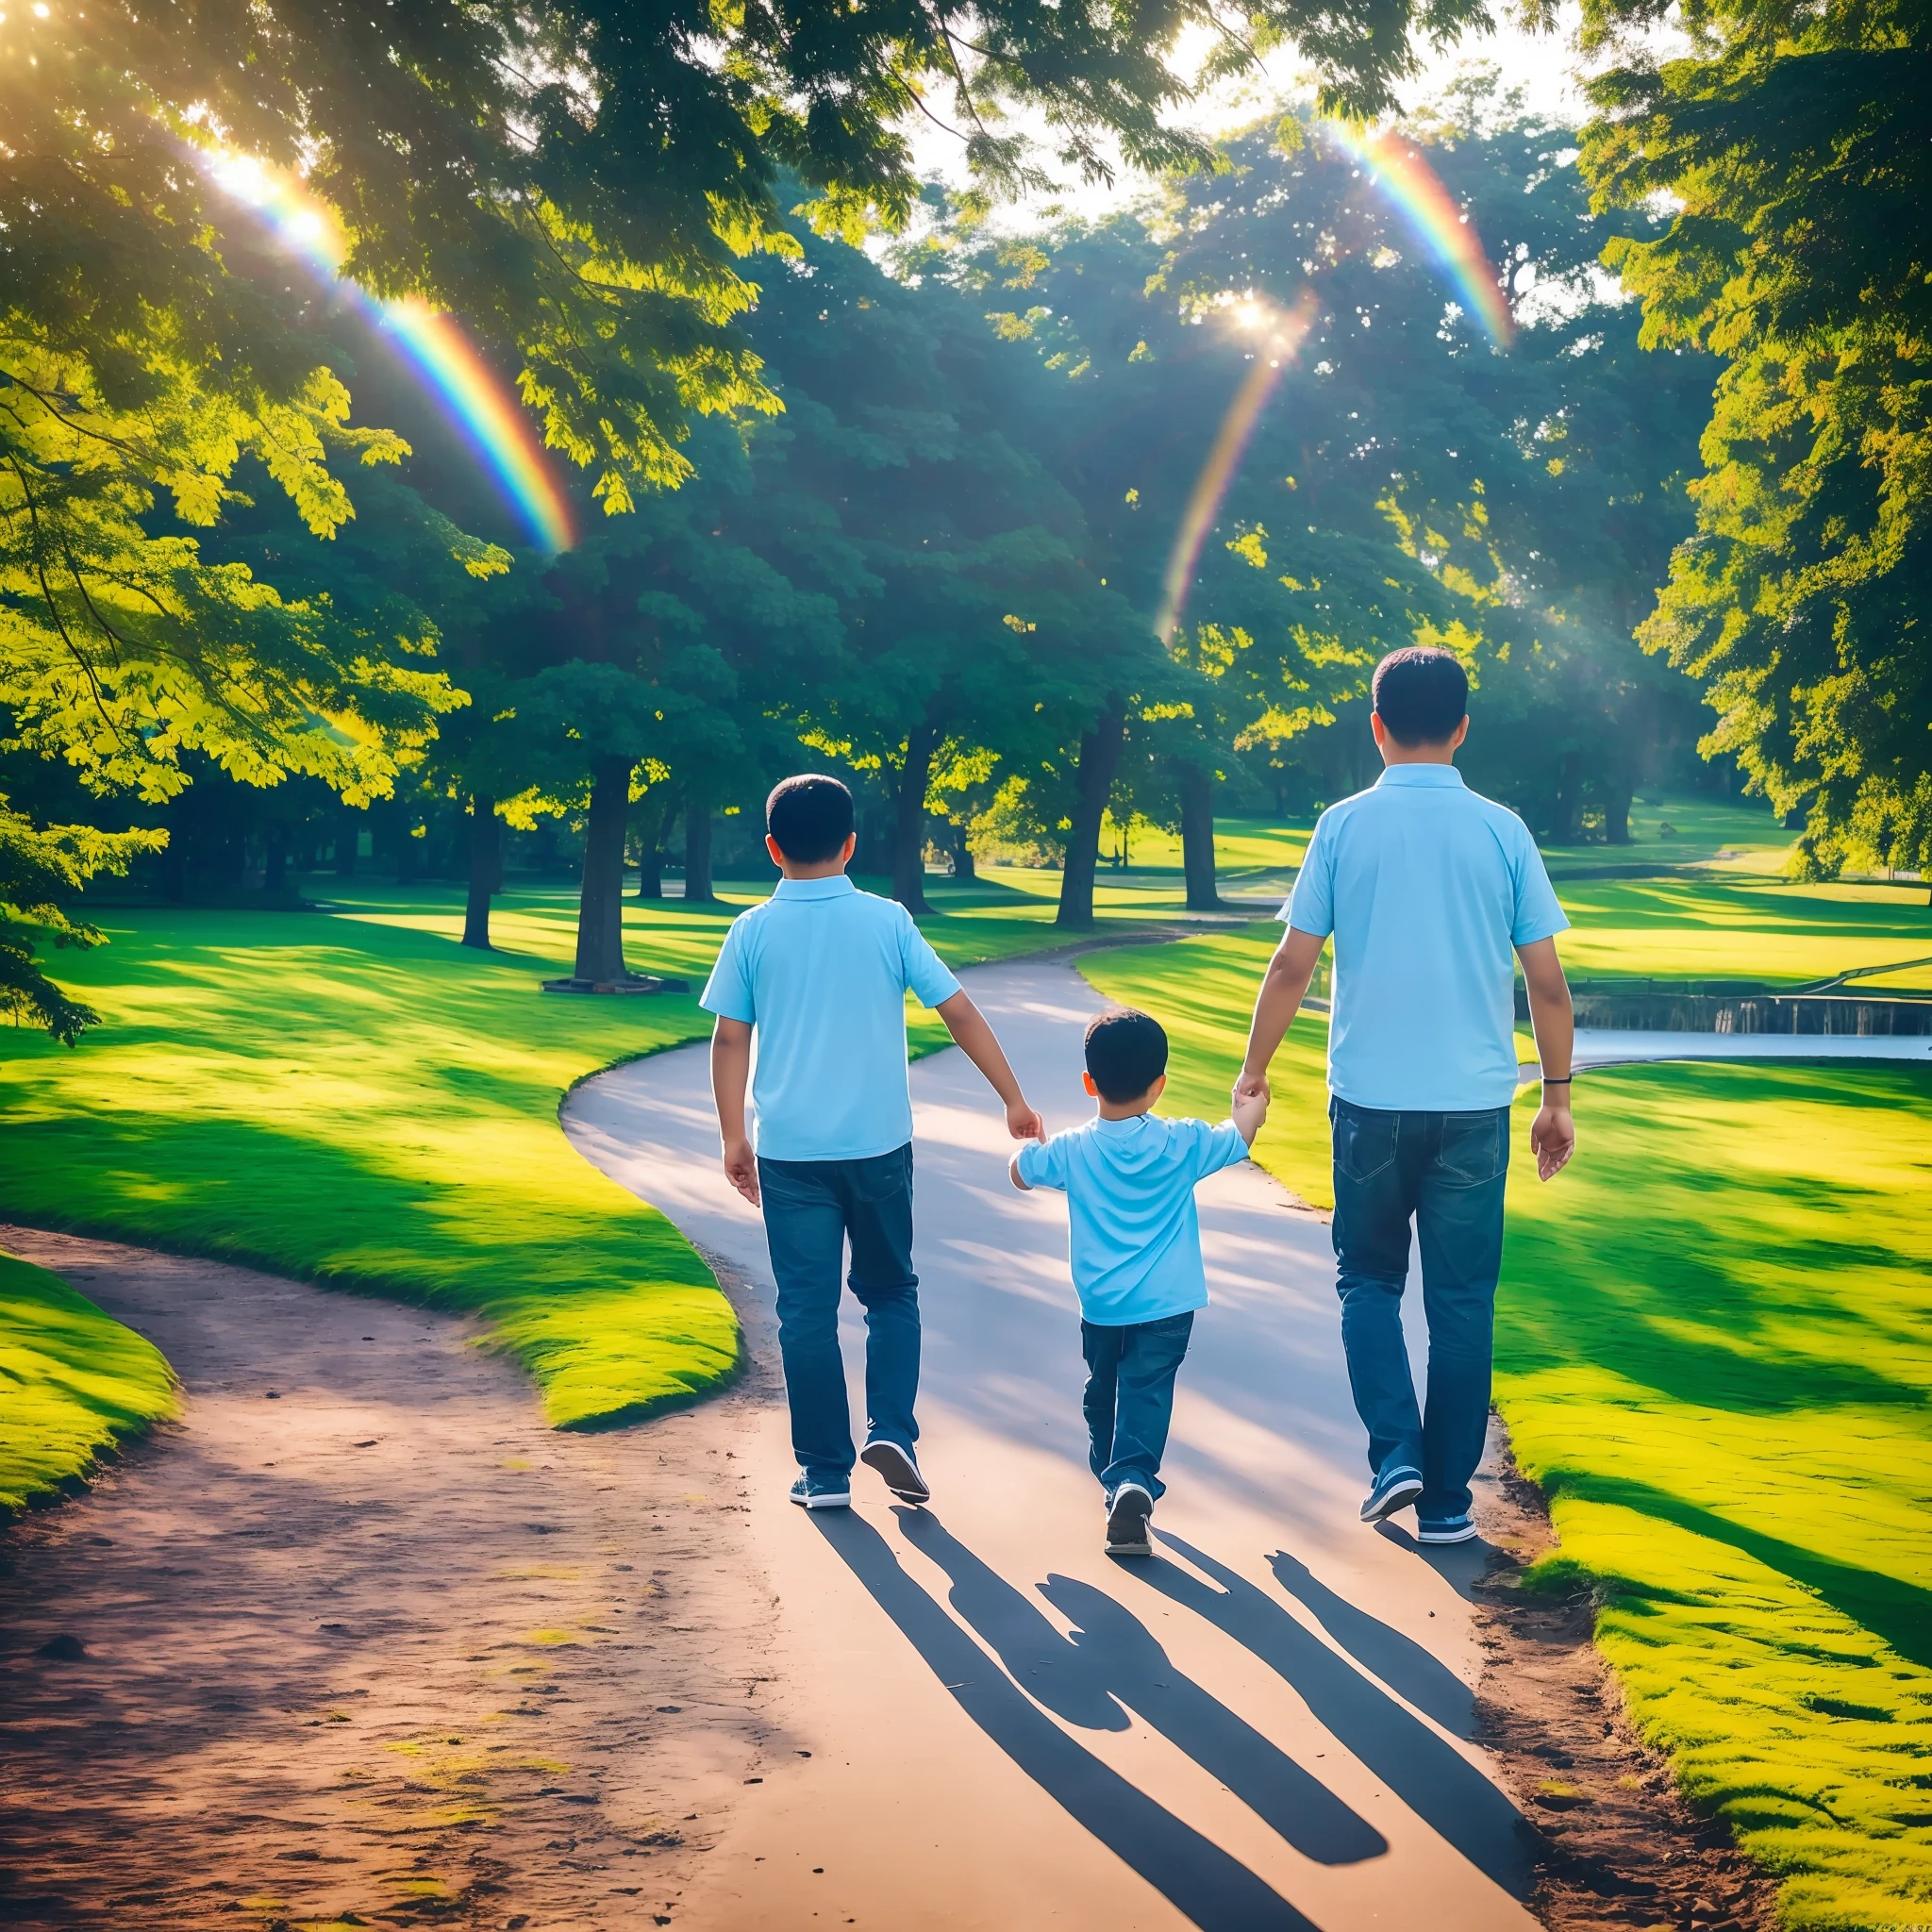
[1136,1530,1534,1897]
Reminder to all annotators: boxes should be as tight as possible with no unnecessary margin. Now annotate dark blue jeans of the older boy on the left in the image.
[758,1141,920,1478]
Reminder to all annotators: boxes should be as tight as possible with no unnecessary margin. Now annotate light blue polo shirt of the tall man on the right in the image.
[1281,765,1569,1113]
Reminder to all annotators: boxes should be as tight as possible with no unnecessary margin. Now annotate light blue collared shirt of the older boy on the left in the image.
[697,874,960,1161]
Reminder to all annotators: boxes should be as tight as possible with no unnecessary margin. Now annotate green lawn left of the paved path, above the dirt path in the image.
[0,879,1145,1427]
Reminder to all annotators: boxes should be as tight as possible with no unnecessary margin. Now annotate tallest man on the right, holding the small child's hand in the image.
[1235,647,1576,1543]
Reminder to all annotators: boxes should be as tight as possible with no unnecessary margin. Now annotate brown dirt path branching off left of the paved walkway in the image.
[0,1226,791,1932]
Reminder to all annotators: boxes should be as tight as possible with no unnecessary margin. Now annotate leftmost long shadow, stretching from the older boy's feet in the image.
[811,1511,1318,1932]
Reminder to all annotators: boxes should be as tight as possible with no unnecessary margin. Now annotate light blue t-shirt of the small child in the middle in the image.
[1020,1113,1248,1327]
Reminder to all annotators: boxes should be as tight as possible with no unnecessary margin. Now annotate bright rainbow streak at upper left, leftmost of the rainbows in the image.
[210,155,577,557]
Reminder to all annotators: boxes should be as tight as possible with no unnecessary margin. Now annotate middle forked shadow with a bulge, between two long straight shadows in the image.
[900,1511,1390,1864]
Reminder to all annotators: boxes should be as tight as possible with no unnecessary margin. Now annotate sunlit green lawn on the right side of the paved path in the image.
[1082,923,1932,1932]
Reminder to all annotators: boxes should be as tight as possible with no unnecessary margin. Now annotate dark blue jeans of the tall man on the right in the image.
[1329,1099,1508,1523]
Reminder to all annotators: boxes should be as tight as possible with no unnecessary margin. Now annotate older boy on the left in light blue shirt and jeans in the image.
[699,773,1045,1508]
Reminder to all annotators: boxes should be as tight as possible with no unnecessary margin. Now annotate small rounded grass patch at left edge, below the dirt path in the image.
[0,1254,174,1519]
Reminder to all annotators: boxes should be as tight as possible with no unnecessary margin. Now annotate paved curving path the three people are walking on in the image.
[564,962,1534,1932]
